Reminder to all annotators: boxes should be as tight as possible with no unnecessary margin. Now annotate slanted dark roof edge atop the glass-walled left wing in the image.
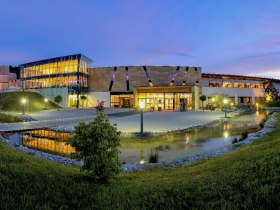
[19,54,92,67]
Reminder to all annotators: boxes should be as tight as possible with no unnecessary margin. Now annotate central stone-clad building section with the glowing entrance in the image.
[89,66,201,110]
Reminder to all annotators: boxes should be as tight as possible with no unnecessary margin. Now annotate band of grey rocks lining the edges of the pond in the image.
[0,110,277,172]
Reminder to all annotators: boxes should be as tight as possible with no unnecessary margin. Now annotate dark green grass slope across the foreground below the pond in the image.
[0,111,280,209]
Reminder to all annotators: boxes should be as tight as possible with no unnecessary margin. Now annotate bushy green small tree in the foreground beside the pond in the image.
[68,112,121,182]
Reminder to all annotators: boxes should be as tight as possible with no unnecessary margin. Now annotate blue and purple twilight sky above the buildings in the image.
[0,0,280,79]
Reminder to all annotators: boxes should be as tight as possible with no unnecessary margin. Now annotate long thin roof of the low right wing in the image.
[202,73,280,82]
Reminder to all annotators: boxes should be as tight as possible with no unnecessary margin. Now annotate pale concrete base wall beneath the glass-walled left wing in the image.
[26,87,68,108]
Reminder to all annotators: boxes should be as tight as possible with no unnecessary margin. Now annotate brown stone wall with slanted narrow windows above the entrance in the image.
[88,66,201,92]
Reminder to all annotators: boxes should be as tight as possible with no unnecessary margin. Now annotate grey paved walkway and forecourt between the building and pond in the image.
[0,109,224,133]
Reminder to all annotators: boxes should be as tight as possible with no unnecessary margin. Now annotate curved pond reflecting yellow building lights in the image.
[2,112,267,163]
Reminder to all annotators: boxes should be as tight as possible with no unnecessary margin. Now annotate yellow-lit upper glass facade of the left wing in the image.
[20,54,91,92]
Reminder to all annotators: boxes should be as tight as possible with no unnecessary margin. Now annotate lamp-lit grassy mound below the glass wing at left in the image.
[0,92,59,113]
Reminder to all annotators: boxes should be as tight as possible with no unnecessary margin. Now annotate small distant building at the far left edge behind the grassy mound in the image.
[0,66,20,91]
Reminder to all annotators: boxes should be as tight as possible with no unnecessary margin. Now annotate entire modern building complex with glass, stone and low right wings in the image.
[20,54,280,111]
